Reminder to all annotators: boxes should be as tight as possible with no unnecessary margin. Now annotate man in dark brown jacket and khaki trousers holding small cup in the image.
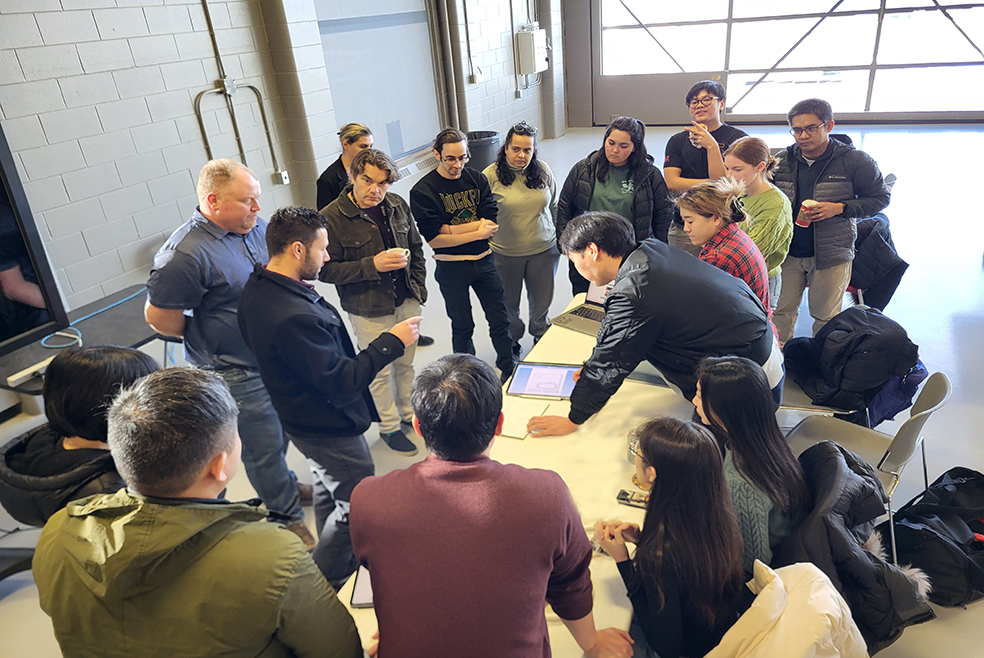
[319,148,427,456]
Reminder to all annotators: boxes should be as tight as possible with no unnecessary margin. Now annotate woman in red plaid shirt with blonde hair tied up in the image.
[676,178,772,318]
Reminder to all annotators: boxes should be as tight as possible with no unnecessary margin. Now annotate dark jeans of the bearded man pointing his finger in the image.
[287,434,376,591]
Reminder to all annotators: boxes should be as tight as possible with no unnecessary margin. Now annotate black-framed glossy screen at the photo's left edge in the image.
[0,126,68,356]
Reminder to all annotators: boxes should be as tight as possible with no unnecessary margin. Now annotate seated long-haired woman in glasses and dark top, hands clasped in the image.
[595,417,754,658]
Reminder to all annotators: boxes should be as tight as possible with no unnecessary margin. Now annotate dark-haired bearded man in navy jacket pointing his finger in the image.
[239,206,421,589]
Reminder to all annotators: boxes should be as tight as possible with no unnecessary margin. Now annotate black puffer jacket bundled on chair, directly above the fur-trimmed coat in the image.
[783,306,919,410]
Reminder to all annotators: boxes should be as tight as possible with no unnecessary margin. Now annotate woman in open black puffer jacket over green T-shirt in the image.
[557,117,673,295]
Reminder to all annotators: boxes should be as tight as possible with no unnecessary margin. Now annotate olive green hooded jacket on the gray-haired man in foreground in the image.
[34,489,362,658]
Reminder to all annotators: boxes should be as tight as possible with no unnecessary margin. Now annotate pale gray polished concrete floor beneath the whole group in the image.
[0,121,984,658]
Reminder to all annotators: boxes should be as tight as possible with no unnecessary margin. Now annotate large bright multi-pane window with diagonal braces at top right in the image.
[596,0,984,117]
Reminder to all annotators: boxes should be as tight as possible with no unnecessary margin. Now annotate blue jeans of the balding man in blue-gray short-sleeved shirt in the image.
[215,368,304,523]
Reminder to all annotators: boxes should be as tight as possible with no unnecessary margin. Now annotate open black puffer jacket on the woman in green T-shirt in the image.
[557,151,673,243]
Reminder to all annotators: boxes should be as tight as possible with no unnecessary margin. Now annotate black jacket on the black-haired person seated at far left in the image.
[0,425,126,526]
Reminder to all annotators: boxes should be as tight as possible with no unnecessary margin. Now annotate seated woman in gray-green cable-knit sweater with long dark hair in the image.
[694,356,812,573]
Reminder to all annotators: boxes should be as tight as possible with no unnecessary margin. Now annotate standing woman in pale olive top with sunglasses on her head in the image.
[482,121,560,355]
